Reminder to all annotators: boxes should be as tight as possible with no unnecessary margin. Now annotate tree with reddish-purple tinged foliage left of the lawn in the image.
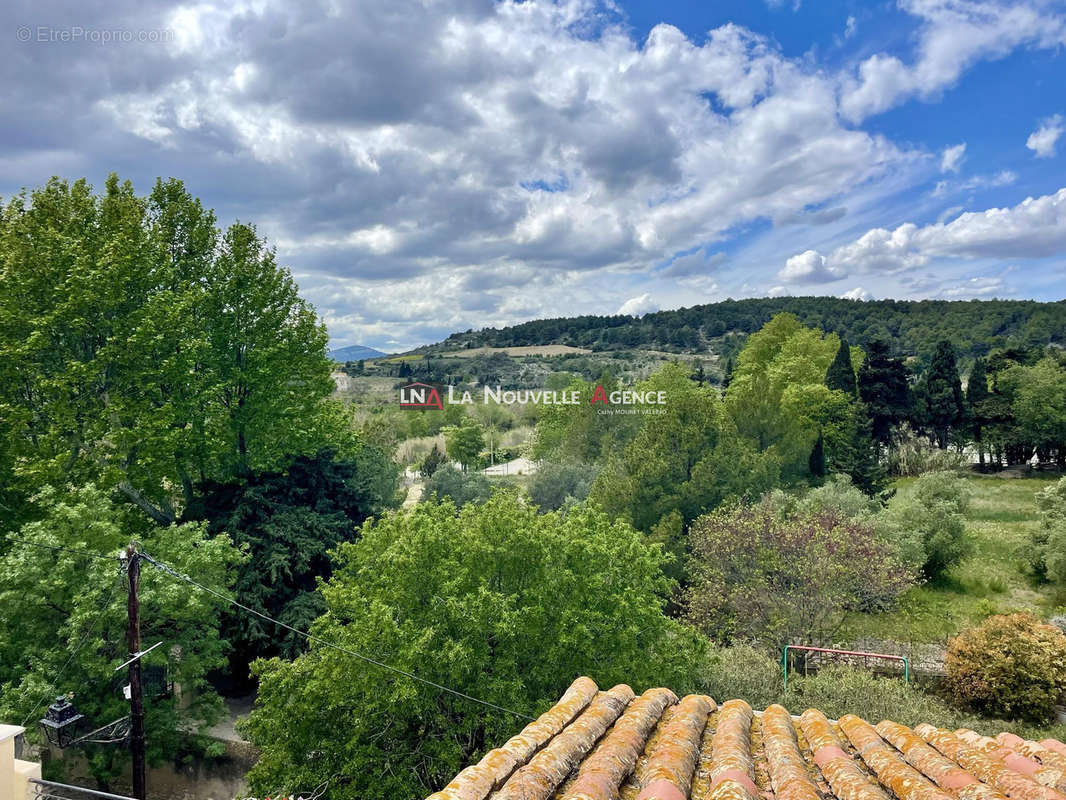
[685,502,914,646]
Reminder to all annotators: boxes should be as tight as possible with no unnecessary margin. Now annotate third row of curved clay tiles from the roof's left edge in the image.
[563,689,677,800]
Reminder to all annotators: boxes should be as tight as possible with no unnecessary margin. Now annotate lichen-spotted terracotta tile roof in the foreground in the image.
[427,677,1066,800]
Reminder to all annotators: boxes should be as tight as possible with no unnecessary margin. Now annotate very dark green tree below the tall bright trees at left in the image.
[184,447,397,688]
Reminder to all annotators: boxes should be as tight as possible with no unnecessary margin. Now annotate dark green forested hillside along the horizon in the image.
[436,298,1066,358]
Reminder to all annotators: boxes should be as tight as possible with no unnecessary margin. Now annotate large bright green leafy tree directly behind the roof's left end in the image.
[243,493,706,800]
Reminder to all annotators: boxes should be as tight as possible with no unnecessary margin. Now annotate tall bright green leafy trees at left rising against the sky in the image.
[0,175,336,525]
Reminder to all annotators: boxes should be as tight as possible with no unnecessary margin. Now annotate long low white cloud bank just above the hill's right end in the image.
[778,189,1066,283]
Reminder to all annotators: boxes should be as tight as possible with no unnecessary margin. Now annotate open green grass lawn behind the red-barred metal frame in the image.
[843,476,1066,642]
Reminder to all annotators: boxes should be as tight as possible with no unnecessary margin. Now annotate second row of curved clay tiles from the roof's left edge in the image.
[492,684,634,800]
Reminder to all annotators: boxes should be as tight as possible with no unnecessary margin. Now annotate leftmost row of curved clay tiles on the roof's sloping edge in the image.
[426,677,598,800]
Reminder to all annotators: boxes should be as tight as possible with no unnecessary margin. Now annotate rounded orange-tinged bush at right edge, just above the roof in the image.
[946,613,1066,722]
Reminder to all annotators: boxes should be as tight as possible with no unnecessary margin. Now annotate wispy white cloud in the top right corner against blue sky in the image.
[841,0,1066,122]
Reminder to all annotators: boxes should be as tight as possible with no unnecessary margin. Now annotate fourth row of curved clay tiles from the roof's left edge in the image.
[636,694,715,800]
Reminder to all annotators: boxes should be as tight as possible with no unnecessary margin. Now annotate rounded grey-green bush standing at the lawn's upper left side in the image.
[877,471,970,578]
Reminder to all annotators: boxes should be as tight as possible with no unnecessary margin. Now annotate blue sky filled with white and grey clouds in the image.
[0,0,1066,352]
